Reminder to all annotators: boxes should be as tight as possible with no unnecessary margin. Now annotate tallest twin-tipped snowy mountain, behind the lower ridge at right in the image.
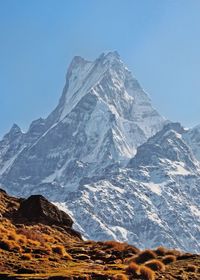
[0,52,165,200]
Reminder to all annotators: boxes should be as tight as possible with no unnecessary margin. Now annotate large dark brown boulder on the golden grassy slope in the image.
[16,195,73,228]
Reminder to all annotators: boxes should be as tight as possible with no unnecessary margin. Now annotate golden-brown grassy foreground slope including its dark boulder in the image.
[0,190,200,280]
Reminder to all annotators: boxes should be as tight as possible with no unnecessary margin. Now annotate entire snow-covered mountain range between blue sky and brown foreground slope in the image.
[0,52,200,251]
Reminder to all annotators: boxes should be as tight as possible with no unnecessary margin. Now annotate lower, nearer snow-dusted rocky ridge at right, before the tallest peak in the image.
[59,124,200,252]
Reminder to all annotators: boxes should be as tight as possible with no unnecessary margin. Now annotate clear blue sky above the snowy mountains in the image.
[0,0,200,136]
